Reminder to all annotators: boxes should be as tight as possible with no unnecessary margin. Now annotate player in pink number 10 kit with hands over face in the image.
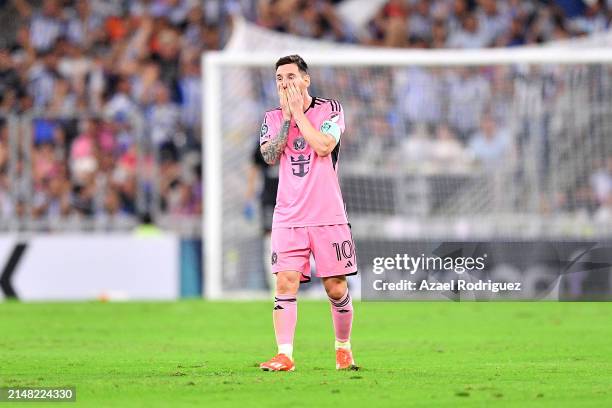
[259,55,357,371]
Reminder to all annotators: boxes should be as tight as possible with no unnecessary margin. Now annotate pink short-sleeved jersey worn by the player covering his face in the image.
[259,97,348,229]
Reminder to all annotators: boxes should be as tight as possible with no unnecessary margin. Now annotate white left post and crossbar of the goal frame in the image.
[202,47,612,299]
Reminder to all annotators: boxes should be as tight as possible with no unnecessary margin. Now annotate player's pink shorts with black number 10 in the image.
[271,224,357,282]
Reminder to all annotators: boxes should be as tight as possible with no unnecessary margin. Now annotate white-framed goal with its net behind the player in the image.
[203,49,612,298]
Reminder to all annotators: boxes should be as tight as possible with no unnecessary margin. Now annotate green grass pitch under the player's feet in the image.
[0,301,612,408]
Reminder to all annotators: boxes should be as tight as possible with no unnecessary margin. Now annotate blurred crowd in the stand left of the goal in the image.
[0,0,225,225]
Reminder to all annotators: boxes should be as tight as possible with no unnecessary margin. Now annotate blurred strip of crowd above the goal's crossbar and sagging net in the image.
[256,0,612,48]
